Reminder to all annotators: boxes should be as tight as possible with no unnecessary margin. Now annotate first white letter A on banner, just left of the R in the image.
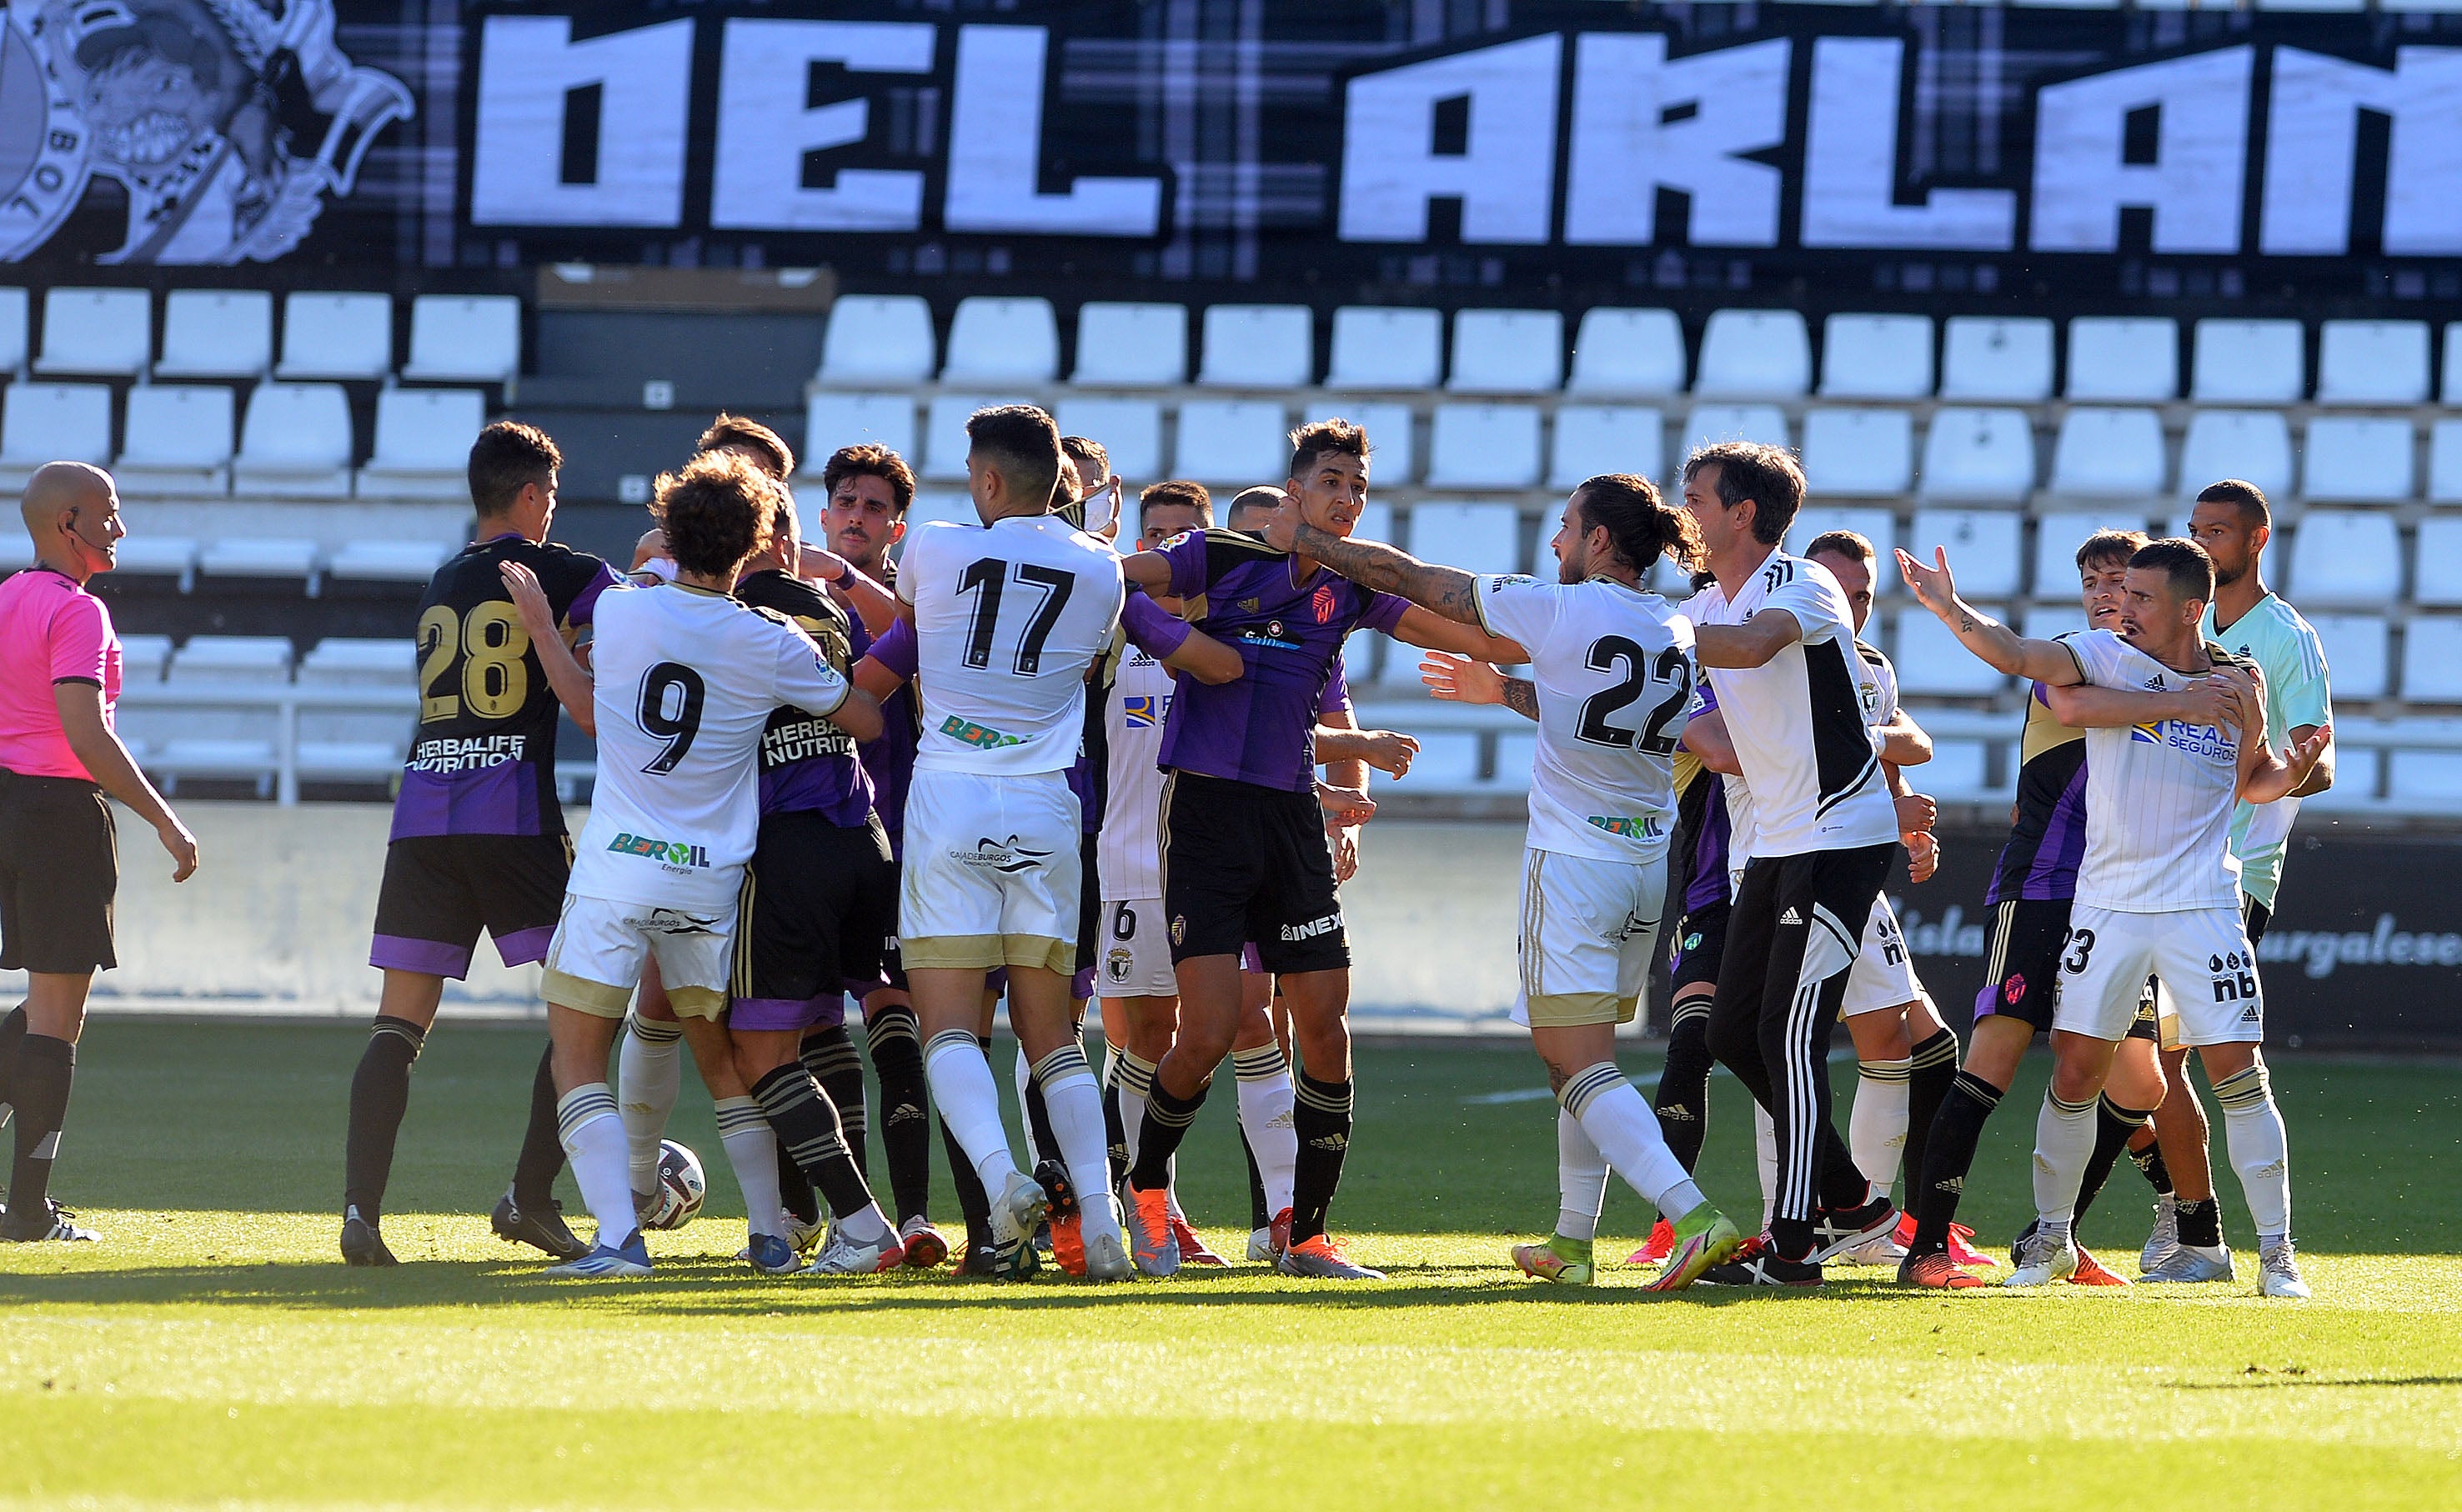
[1339,34,1563,243]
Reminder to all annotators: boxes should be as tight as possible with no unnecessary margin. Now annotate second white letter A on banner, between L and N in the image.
[2026,47,2255,251]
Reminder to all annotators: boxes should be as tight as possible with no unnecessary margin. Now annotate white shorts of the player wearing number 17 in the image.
[899,769,1083,975]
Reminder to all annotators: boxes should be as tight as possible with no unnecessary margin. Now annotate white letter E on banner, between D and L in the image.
[709,20,938,232]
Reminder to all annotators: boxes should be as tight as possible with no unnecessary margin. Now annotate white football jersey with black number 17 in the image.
[899,514,1121,776]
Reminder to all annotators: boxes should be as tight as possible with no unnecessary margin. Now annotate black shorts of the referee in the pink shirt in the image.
[0,771,121,978]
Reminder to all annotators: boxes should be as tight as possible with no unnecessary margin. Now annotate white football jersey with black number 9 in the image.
[569,583,847,909]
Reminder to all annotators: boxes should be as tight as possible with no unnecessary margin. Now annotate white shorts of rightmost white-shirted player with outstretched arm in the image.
[2051,904,2265,1044]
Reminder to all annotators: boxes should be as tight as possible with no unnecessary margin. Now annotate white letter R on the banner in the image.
[1563,32,1790,246]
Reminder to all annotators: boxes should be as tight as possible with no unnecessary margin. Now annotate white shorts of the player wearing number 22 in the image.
[1514,849,1667,1027]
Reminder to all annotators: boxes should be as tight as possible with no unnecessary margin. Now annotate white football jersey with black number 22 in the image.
[1472,576,1694,864]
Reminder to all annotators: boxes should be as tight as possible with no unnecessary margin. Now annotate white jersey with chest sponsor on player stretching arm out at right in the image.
[2061,630,2240,914]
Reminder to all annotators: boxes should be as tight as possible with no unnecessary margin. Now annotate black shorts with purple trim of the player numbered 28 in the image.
[367,835,574,980]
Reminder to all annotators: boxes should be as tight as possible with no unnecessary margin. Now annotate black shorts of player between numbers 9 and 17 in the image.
[726,813,899,1029]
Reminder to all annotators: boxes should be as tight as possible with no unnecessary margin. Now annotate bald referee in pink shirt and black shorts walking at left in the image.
[0,463,197,1244]
